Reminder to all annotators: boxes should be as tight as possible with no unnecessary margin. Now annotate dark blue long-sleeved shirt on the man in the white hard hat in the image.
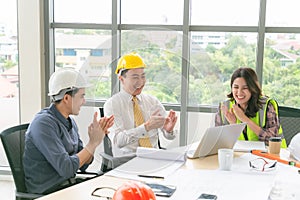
[23,104,87,193]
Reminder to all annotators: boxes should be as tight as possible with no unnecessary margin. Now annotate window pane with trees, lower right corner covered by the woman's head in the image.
[188,32,257,106]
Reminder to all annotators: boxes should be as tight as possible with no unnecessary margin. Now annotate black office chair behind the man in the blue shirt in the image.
[0,124,42,200]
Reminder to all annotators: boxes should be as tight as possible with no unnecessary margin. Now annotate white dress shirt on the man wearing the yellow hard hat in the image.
[104,90,175,152]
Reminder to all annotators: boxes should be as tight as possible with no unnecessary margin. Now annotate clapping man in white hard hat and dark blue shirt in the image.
[23,68,114,194]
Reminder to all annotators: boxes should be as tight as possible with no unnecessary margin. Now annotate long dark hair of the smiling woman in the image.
[227,67,263,117]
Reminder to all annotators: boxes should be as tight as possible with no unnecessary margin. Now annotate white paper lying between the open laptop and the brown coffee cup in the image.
[233,140,267,152]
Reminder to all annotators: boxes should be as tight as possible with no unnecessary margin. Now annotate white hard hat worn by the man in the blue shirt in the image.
[48,68,88,100]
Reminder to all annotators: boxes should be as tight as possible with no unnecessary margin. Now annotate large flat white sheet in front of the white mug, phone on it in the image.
[163,169,275,200]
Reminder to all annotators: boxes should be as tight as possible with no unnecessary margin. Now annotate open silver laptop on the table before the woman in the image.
[187,123,246,158]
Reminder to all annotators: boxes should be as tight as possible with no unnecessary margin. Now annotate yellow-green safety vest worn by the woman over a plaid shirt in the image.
[220,97,287,148]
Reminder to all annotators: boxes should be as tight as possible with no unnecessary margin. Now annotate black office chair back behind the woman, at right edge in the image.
[278,106,300,145]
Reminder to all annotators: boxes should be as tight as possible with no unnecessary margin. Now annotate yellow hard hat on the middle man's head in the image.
[115,52,146,74]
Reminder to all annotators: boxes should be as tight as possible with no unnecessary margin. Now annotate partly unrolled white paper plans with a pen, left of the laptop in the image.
[106,147,186,182]
